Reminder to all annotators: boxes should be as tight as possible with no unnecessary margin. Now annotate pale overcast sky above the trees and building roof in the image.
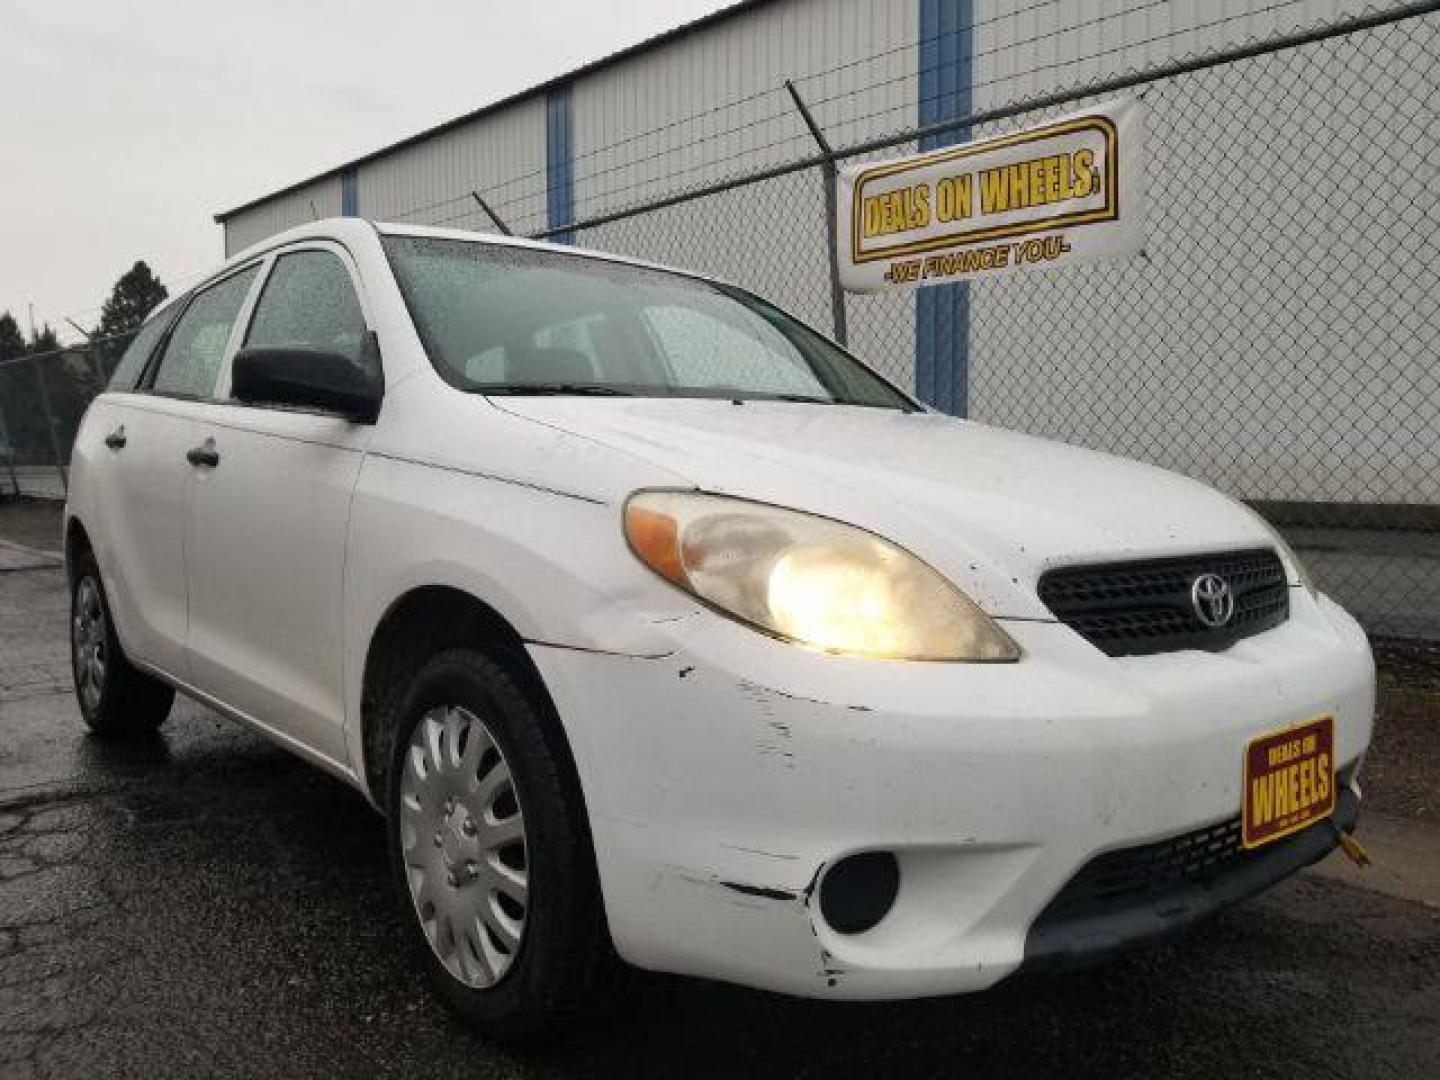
[0,0,730,340]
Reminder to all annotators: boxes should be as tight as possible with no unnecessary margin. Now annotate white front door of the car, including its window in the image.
[187,242,372,765]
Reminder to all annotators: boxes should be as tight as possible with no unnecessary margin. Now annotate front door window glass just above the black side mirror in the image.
[245,251,366,360]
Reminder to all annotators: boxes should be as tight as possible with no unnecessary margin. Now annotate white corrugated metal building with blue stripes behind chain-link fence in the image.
[217,0,1440,504]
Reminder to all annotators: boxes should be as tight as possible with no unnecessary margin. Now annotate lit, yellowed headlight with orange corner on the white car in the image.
[625,491,1020,661]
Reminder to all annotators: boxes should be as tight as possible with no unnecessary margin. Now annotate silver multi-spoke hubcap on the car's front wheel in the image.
[400,706,530,988]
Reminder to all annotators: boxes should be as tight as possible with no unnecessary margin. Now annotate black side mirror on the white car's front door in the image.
[230,334,384,423]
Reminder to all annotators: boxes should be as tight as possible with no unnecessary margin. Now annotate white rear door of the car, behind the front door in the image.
[85,265,258,680]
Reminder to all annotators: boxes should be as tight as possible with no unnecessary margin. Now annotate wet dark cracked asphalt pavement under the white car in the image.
[0,547,1440,1080]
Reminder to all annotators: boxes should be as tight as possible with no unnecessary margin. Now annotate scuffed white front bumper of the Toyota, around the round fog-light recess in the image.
[531,590,1374,998]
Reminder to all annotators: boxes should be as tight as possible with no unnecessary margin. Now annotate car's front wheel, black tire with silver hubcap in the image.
[386,648,615,1041]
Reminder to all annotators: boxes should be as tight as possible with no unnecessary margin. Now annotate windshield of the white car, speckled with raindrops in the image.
[384,236,916,409]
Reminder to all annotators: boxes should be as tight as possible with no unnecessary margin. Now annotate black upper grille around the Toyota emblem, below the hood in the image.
[1040,549,1290,657]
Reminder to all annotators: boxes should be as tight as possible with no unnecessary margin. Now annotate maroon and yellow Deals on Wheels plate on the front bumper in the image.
[1241,716,1335,848]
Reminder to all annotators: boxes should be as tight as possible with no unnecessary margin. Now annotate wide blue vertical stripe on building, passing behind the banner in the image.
[914,0,975,416]
